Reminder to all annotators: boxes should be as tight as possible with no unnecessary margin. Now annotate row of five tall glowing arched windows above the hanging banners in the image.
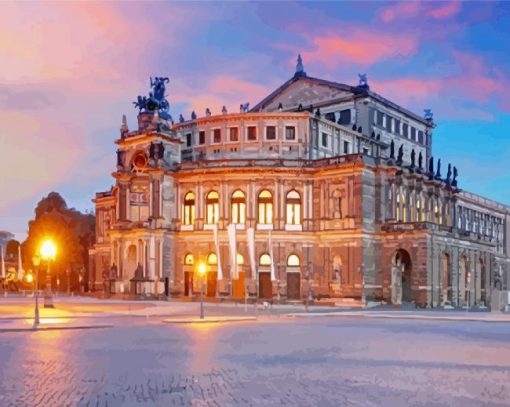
[182,189,301,225]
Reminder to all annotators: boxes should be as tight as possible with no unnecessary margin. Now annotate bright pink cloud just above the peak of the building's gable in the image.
[303,28,418,69]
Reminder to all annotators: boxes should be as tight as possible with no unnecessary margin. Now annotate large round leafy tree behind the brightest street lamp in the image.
[22,192,95,289]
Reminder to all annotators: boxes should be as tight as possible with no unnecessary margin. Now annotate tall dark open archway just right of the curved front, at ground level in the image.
[391,249,413,305]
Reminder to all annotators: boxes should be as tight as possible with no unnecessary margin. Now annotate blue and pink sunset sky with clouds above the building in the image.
[0,1,510,239]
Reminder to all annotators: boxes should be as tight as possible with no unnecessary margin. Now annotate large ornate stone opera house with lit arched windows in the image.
[90,61,510,307]
